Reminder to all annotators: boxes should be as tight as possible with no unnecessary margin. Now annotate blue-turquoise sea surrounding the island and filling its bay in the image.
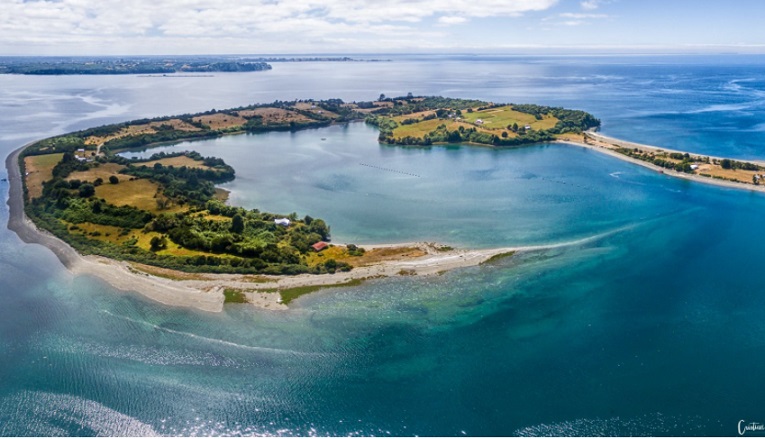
[0,55,765,436]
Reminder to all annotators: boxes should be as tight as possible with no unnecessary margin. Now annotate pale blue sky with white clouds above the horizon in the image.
[0,0,765,55]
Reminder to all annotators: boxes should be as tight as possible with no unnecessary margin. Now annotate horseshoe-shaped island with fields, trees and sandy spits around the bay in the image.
[6,94,763,311]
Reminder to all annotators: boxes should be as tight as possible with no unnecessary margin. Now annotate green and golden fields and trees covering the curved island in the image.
[19,95,599,276]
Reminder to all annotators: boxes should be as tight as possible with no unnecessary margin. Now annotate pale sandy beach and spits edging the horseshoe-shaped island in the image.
[5,132,765,312]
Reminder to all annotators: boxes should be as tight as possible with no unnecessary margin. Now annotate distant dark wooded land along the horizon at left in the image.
[0,56,380,75]
